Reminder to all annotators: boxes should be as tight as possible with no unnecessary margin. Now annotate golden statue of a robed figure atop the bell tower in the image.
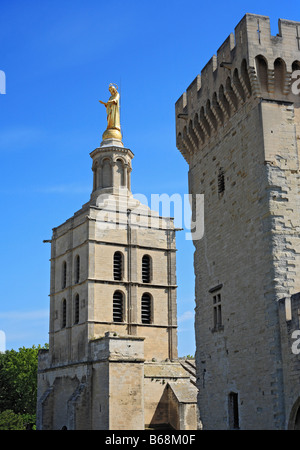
[99,83,122,141]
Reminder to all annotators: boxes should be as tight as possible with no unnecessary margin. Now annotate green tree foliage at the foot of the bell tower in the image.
[0,345,47,415]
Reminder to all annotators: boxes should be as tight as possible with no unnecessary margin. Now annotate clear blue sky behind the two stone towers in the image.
[0,0,300,355]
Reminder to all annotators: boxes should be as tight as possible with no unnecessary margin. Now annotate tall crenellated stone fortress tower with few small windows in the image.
[176,14,300,429]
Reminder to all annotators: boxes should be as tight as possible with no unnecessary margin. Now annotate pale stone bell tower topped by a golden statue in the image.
[37,85,197,430]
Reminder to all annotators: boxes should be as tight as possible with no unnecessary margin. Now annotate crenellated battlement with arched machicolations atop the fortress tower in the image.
[175,14,300,162]
